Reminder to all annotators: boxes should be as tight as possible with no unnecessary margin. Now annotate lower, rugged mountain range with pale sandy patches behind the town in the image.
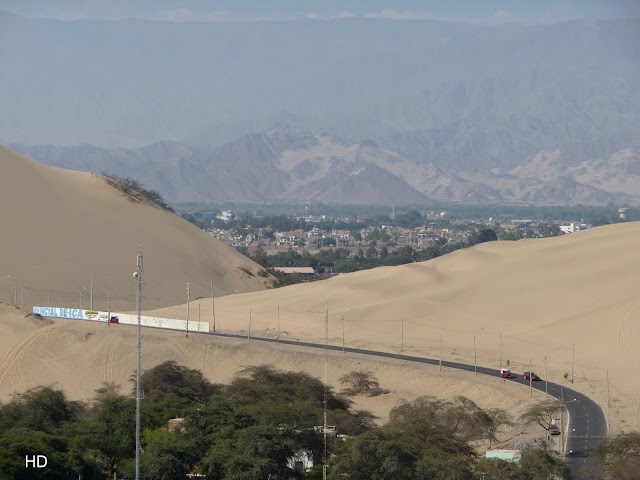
[11,126,640,204]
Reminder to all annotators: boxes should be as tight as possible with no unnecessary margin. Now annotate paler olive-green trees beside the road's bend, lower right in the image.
[330,397,569,480]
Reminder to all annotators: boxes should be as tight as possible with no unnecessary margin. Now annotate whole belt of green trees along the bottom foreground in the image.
[0,361,592,480]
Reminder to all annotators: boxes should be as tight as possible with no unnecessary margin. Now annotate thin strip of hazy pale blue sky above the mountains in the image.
[0,0,640,24]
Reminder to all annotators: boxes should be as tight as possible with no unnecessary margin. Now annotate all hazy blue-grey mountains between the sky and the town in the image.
[0,13,640,204]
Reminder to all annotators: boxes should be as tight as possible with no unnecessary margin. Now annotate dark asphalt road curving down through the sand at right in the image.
[202,332,608,479]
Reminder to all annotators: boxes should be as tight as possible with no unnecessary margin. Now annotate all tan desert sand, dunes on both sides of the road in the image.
[0,149,640,433]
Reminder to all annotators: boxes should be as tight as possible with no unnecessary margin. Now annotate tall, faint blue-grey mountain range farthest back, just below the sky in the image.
[0,13,640,171]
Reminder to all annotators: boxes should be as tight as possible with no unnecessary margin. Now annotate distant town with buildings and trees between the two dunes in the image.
[177,205,635,286]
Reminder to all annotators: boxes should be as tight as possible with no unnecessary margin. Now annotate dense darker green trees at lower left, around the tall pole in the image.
[0,361,374,480]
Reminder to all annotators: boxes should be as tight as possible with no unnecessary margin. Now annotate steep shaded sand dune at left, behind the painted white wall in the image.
[0,146,266,310]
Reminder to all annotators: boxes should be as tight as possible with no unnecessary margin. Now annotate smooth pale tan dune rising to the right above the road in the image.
[151,223,640,432]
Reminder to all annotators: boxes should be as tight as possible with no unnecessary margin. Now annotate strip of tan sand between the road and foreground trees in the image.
[0,304,543,448]
